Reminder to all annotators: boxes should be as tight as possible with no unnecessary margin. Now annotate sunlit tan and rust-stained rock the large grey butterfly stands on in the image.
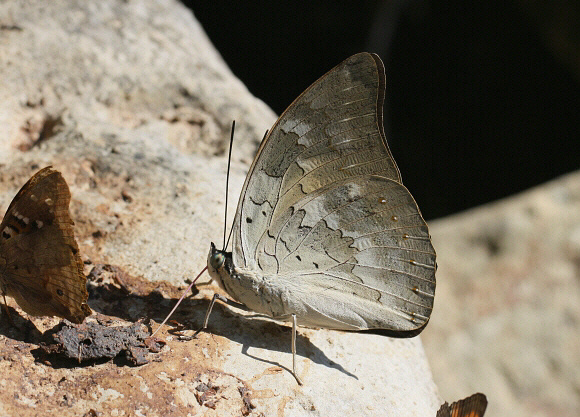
[0,0,441,417]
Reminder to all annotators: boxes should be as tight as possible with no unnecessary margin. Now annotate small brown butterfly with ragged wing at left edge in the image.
[0,167,91,323]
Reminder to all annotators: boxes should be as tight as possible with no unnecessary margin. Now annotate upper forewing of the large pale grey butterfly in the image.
[232,53,400,268]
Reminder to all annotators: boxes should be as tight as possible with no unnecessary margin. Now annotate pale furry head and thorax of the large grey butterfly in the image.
[207,243,289,319]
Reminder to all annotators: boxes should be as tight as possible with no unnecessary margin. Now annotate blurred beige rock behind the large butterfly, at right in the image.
[422,172,580,417]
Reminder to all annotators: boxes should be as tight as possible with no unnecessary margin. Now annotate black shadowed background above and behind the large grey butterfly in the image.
[184,0,580,219]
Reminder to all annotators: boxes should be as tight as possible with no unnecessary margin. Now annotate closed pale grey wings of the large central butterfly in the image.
[233,53,435,337]
